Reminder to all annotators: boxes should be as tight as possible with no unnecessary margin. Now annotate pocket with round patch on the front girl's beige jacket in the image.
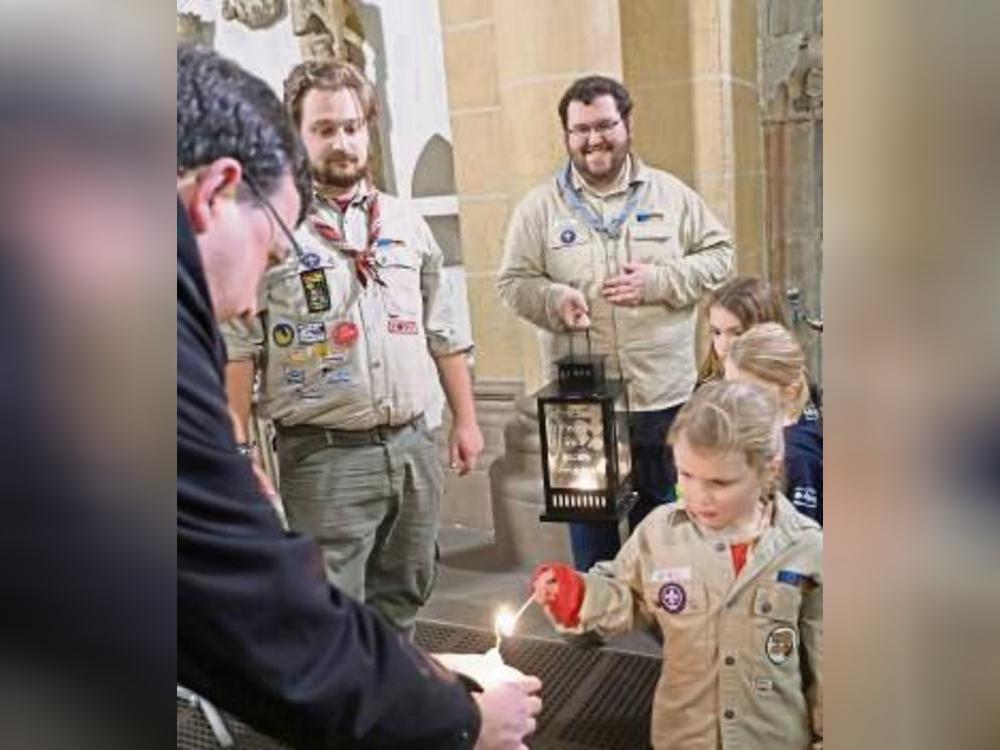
[751,584,802,677]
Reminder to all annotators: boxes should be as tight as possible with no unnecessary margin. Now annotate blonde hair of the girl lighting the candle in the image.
[667,380,785,498]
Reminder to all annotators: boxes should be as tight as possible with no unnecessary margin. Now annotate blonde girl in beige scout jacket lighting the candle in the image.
[533,381,823,750]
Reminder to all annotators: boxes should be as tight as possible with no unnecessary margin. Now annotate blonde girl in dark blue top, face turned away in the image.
[725,323,823,525]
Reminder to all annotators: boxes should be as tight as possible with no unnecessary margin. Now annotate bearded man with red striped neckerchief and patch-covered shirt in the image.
[227,62,483,632]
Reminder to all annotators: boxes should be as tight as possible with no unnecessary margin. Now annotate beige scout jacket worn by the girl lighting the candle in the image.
[557,495,823,750]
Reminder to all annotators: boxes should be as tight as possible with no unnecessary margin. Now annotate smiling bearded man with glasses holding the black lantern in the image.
[498,76,733,570]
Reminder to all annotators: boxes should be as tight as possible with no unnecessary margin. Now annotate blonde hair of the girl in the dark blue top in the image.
[729,323,809,419]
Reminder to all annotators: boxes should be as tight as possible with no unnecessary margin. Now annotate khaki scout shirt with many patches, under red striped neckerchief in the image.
[223,188,472,430]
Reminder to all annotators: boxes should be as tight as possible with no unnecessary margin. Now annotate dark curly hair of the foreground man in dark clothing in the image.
[177,45,312,222]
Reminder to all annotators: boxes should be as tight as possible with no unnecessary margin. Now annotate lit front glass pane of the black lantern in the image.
[545,402,608,490]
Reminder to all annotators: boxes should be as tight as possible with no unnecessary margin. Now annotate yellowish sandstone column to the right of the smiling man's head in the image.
[621,0,767,275]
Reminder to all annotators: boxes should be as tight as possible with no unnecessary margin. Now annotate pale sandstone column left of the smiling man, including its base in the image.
[440,0,622,566]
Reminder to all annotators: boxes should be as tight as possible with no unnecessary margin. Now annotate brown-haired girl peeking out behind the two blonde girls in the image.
[698,276,788,383]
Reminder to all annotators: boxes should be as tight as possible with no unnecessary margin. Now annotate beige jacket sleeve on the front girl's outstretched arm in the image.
[576,529,645,638]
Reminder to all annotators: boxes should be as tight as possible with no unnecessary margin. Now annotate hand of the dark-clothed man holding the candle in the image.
[473,677,542,750]
